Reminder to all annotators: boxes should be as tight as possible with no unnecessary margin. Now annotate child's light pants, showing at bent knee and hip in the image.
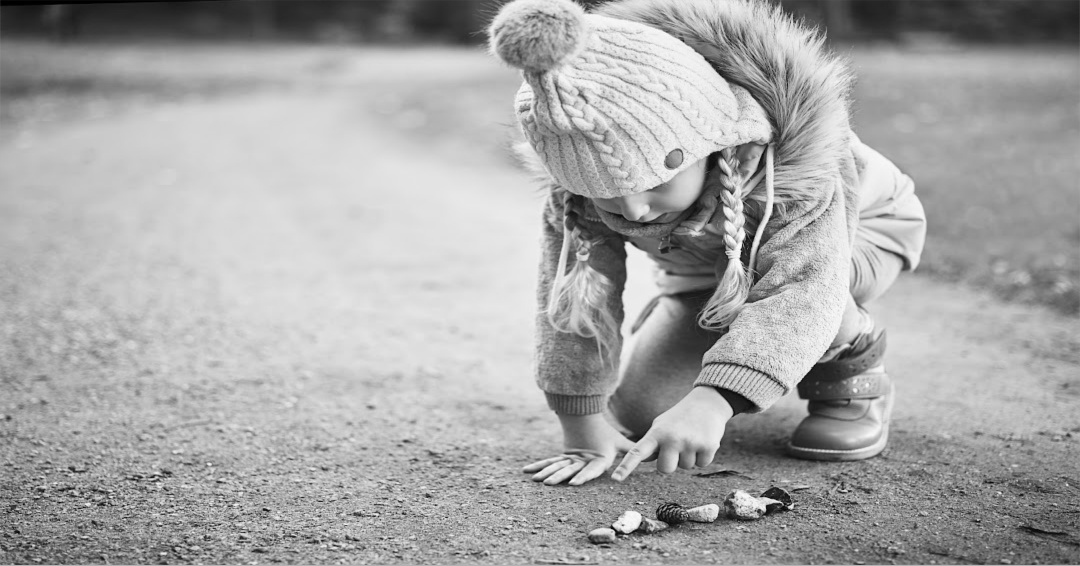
[608,239,904,437]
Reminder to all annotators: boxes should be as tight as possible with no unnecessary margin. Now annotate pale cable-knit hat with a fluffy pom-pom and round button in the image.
[489,0,771,199]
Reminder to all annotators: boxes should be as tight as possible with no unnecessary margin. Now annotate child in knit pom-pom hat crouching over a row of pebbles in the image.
[490,0,926,485]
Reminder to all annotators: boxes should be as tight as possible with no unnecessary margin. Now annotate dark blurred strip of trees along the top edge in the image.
[0,0,1080,44]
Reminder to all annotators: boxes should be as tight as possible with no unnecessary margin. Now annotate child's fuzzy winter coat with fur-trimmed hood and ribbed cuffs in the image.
[527,0,926,415]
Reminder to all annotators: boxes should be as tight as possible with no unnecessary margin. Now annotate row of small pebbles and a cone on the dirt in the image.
[589,487,795,544]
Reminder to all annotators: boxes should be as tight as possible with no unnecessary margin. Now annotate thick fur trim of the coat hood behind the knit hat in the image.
[595,0,854,202]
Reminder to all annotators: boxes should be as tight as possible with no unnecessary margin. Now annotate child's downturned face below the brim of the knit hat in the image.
[593,159,706,224]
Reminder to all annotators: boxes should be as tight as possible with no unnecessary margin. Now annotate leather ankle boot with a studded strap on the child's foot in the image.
[787,331,893,460]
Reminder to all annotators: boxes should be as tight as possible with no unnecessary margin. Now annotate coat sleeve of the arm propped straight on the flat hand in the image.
[536,193,626,415]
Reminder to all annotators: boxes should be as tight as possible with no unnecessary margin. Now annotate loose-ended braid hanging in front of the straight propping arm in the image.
[548,189,621,366]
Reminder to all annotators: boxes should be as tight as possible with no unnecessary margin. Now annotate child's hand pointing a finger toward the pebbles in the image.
[611,387,734,482]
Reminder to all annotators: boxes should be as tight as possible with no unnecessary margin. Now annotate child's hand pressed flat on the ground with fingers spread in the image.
[522,415,634,485]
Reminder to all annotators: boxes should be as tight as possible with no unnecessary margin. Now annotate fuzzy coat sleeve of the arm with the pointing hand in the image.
[694,180,854,413]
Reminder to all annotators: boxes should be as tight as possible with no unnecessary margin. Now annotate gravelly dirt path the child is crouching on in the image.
[0,81,1080,564]
